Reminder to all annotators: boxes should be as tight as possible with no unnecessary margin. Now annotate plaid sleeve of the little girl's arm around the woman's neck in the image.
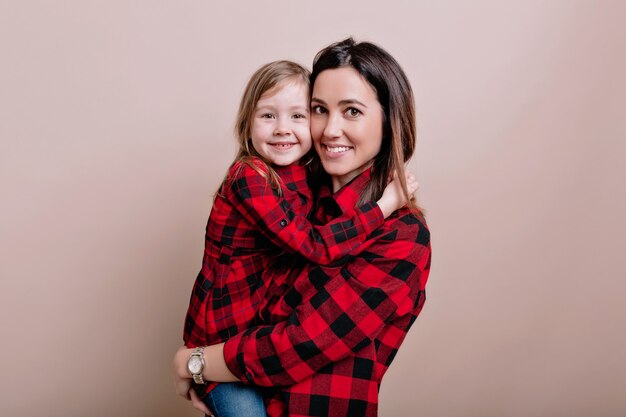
[225,164,385,265]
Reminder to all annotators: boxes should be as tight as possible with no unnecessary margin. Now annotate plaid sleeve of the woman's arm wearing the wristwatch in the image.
[219,214,430,386]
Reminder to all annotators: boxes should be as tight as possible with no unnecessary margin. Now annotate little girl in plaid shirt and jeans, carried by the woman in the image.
[184,61,416,417]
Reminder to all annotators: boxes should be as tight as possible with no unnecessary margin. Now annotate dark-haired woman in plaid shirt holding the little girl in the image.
[174,39,430,416]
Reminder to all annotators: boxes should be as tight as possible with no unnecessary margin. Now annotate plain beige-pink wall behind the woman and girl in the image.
[0,0,626,417]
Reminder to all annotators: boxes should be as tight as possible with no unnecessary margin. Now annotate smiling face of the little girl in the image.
[250,80,311,166]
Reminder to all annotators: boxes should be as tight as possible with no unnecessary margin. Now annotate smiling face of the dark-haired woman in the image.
[311,67,384,191]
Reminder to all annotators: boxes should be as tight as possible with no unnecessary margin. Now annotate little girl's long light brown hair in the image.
[218,60,311,196]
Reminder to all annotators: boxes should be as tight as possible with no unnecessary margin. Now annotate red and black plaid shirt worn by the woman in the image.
[224,172,431,417]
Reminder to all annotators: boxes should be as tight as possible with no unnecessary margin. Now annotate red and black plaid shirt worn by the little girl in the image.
[183,160,384,395]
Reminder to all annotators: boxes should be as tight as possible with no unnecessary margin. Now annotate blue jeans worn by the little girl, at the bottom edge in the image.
[203,382,267,417]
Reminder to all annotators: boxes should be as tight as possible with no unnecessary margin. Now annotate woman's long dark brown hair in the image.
[311,38,417,208]
